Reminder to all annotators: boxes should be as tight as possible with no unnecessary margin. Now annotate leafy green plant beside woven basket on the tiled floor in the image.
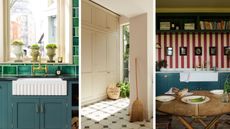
[117,82,130,98]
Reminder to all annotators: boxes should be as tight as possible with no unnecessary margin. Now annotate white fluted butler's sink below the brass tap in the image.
[12,78,67,95]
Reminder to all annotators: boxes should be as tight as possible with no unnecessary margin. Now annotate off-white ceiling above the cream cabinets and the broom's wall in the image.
[92,0,153,17]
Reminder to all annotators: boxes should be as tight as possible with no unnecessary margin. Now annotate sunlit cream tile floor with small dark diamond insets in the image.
[81,98,152,129]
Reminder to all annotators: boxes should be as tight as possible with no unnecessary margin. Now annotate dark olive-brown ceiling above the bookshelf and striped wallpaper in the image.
[156,0,230,8]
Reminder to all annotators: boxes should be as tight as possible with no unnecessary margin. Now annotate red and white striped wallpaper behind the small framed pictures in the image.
[156,32,230,68]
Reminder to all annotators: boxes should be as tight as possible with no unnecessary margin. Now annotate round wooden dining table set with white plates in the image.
[156,91,230,129]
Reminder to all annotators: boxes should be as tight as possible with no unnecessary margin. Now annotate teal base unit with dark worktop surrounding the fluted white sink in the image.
[0,76,78,129]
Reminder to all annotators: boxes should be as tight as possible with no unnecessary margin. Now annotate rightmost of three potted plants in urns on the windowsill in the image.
[46,43,57,62]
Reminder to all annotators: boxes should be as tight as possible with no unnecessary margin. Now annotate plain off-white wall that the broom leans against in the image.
[130,13,153,120]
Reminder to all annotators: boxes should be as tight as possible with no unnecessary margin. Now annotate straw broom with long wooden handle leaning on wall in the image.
[130,58,143,122]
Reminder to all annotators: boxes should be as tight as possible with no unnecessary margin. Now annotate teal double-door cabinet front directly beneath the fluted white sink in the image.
[12,97,70,129]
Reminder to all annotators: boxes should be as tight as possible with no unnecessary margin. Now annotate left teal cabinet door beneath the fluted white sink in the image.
[12,98,39,129]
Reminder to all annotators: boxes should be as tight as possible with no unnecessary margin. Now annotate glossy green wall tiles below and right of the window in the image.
[0,0,79,76]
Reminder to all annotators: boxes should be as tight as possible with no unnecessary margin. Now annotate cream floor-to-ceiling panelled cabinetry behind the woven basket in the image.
[81,1,119,105]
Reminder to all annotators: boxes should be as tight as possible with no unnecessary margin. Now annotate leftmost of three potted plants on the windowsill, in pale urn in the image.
[11,40,24,62]
